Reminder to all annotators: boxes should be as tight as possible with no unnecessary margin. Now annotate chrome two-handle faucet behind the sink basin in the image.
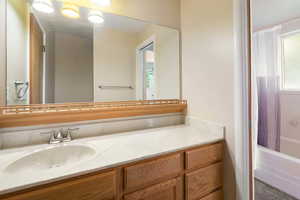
[41,128,79,144]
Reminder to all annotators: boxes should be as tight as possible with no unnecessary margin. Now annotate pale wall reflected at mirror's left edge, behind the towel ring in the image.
[7,0,29,105]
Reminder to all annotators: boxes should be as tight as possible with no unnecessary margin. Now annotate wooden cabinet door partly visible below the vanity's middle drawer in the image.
[124,178,183,200]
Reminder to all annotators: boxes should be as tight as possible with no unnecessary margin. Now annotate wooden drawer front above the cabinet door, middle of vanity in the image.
[124,154,183,192]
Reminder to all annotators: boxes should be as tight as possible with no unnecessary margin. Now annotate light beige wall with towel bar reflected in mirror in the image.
[94,27,137,101]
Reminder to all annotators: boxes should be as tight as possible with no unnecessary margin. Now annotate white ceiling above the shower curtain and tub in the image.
[252,0,300,31]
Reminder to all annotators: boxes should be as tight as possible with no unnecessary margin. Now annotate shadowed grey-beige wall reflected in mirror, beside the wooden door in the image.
[54,32,93,103]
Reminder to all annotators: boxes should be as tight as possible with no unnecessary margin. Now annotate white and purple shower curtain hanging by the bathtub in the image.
[252,26,281,151]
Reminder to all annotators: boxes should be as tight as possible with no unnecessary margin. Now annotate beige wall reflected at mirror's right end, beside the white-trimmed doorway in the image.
[137,25,180,99]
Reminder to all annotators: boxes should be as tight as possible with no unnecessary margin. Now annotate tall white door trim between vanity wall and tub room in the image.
[233,0,252,200]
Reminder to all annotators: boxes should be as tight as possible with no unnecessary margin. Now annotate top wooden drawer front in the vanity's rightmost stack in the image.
[185,143,223,169]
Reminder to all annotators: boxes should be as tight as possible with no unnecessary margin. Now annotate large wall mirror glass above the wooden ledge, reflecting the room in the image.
[7,0,180,105]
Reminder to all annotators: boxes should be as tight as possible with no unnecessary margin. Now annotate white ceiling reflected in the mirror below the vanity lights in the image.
[33,1,147,38]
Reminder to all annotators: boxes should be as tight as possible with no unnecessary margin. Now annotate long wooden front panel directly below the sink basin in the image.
[4,172,116,200]
